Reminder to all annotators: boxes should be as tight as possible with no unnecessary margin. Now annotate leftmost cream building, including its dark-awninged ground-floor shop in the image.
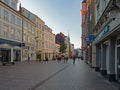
[0,0,22,62]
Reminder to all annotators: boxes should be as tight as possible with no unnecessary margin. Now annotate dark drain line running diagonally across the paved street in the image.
[28,65,69,90]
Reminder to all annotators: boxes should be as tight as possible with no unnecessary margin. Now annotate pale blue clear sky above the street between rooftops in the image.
[20,0,82,48]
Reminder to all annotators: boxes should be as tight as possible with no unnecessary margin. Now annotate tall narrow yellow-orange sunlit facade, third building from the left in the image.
[35,16,45,61]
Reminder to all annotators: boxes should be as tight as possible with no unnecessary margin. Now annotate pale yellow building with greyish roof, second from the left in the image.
[21,7,36,61]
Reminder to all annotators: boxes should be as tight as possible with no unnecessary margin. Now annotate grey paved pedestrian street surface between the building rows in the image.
[0,60,118,90]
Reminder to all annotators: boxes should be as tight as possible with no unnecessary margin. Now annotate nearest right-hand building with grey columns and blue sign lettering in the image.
[94,0,120,81]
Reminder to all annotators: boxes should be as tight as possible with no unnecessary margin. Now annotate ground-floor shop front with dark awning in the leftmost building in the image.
[0,39,21,62]
